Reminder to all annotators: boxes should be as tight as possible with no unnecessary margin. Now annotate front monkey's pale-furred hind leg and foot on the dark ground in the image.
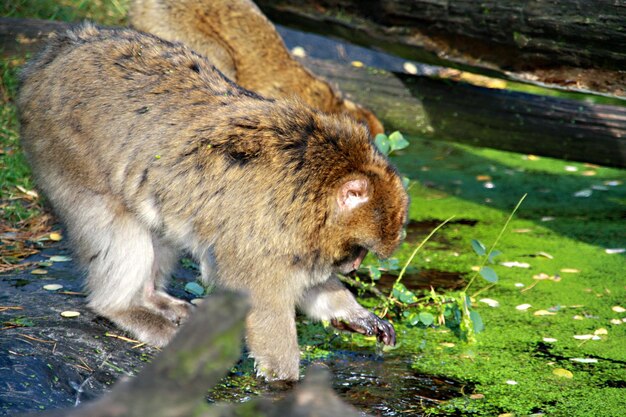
[57,193,188,346]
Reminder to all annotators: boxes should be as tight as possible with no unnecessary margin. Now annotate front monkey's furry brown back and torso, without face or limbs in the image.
[18,25,394,272]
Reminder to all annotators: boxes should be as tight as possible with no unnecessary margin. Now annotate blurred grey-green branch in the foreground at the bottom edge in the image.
[15,292,363,417]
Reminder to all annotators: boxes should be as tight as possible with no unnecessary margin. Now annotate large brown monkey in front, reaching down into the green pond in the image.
[18,25,407,379]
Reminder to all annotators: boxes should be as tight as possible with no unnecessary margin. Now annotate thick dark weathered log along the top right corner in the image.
[257,0,626,96]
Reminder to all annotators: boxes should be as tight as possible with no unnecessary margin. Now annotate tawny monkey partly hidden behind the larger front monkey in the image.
[130,0,384,136]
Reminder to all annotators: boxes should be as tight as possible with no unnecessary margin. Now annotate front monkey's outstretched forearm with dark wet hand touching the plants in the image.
[298,275,396,345]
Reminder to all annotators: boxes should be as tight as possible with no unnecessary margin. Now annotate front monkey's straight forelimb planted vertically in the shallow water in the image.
[246,288,300,381]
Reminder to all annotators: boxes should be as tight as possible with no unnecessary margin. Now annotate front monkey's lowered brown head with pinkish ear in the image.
[310,115,408,273]
